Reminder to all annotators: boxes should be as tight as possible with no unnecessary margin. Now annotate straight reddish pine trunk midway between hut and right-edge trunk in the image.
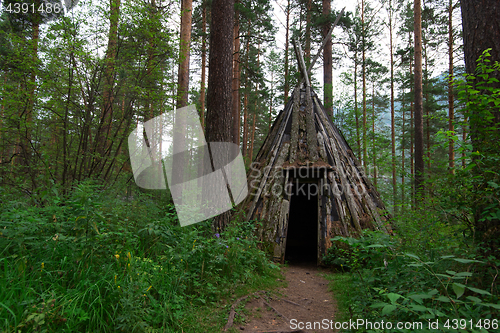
[414,0,424,195]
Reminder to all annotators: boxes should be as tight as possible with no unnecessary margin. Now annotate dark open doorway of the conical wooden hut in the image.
[285,183,318,264]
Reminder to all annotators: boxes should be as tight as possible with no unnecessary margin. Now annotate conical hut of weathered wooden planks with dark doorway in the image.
[243,37,390,264]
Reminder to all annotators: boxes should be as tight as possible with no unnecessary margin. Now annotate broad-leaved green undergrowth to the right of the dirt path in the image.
[324,209,500,333]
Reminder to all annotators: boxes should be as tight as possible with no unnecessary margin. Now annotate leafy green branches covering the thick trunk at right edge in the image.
[457,50,500,246]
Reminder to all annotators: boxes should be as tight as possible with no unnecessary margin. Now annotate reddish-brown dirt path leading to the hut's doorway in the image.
[227,265,335,333]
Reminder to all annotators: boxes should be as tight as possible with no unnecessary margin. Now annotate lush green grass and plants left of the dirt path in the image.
[0,182,276,332]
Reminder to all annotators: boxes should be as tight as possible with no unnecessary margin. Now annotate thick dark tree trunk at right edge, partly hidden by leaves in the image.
[461,0,500,254]
